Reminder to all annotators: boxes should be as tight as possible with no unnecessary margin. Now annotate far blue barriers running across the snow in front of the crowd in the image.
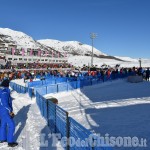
[11,72,134,98]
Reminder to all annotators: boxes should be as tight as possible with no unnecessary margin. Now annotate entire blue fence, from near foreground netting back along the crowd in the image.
[10,71,136,150]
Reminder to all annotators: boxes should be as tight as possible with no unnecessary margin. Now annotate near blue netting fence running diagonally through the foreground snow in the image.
[36,91,112,150]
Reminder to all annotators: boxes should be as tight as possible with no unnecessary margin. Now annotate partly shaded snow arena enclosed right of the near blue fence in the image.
[45,80,150,150]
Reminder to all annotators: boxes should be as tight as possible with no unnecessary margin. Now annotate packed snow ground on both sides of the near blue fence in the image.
[0,79,150,150]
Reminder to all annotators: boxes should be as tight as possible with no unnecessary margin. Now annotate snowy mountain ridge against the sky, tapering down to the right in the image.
[0,28,139,61]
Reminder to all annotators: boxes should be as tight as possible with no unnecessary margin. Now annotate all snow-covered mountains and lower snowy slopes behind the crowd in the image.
[0,28,150,67]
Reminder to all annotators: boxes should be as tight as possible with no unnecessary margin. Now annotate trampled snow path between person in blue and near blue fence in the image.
[0,91,62,150]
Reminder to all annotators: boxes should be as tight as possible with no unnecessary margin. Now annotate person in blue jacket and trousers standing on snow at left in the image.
[0,79,18,147]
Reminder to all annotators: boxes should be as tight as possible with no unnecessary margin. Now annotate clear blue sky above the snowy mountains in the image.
[0,0,150,58]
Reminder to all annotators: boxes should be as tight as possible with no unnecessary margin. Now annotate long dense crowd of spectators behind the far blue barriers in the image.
[0,66,150,82]
